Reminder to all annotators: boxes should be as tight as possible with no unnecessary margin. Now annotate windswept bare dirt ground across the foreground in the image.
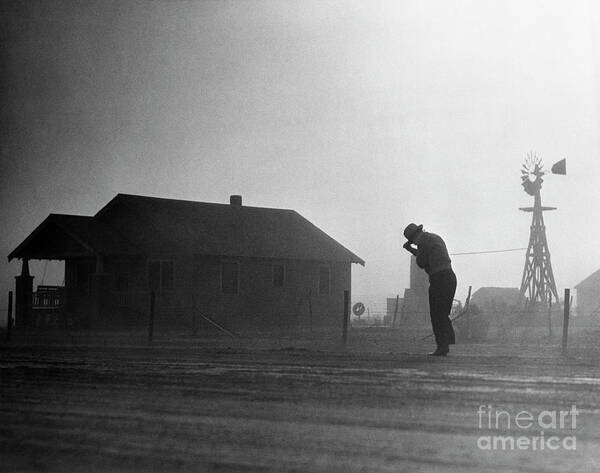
[0,329,600,473]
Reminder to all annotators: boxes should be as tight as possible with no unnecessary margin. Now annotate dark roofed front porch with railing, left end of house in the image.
[8,214,140,328]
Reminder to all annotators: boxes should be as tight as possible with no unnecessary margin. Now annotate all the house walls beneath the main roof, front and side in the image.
[65,252,351,333]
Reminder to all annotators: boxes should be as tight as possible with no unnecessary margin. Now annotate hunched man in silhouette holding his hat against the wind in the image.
[403,223,456,356]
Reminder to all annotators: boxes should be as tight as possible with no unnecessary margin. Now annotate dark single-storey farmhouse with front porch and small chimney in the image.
[8,194,364,329]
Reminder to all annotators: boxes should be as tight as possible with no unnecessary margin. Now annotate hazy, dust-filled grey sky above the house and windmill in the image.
[0,0,600,318]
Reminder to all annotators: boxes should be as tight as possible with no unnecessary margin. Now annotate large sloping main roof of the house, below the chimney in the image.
[9,194,364,265]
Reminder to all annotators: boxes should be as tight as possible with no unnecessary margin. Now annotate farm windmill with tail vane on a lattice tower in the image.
[519,152,566,303]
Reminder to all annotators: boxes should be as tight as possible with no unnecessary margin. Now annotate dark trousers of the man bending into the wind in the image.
[429,269,456,350]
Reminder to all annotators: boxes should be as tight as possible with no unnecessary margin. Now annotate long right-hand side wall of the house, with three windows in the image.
[191,256,351,330]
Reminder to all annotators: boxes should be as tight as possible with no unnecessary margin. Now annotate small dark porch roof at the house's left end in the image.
[8,214,139,261]
